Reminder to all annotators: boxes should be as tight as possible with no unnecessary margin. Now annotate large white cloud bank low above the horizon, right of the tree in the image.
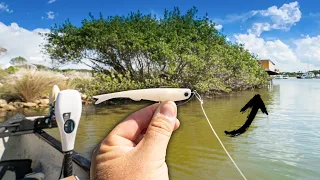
[234,34,320,71]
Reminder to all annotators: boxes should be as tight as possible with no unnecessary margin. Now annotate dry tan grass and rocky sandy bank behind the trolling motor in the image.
[0,67,91,111]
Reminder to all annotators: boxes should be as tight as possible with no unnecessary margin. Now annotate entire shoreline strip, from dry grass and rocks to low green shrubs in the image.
[0,65,263,109]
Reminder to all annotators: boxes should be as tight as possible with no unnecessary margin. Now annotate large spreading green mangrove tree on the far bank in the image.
[44,7,267,92]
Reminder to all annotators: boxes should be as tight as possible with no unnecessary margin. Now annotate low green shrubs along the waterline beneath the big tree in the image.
[73,69,268,97]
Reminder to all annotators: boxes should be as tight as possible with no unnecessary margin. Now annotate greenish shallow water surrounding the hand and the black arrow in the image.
[0,78,320,180]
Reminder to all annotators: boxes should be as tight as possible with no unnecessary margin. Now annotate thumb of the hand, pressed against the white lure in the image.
[139,101,177,160]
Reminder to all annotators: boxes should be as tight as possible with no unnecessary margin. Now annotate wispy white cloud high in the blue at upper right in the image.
[248,2,301,36]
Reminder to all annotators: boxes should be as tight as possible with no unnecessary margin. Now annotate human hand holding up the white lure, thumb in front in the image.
[90,101,180,180]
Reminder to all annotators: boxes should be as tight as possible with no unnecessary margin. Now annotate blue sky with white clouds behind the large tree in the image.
[0,0,320,72]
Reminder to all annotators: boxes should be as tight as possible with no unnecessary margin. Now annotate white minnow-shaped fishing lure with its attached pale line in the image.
[93,88,247,180]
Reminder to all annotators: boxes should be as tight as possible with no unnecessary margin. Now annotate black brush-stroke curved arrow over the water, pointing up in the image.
[224,94,268,137]
